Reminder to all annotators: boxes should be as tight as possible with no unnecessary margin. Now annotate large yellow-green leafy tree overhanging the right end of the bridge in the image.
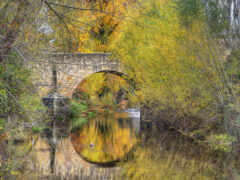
[112,0,218,114]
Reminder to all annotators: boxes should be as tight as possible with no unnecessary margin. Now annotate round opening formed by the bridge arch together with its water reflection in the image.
[71,71,137,164]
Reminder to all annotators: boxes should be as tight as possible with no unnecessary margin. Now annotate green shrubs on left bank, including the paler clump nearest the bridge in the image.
[0,50,46,136]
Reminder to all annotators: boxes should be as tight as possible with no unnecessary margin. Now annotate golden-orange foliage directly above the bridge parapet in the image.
[62,0,134,52]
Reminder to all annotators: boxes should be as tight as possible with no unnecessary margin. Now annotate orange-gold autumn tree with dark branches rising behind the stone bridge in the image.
[50,0,136,52]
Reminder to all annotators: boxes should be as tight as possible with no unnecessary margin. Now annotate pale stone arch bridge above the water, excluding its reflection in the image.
[28,53,122,97]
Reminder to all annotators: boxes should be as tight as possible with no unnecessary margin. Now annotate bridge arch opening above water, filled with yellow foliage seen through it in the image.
[72,70,135,109]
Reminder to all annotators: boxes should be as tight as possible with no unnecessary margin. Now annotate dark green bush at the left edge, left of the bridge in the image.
[0,53,31,115]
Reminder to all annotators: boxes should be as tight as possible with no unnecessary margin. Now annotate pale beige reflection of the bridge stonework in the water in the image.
[33,138,120,180]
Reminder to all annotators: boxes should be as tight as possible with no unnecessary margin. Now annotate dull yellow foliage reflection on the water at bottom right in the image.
[121,133,229,180]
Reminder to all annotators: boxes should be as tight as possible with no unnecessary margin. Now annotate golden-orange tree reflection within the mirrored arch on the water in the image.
[72,113,136,163]
